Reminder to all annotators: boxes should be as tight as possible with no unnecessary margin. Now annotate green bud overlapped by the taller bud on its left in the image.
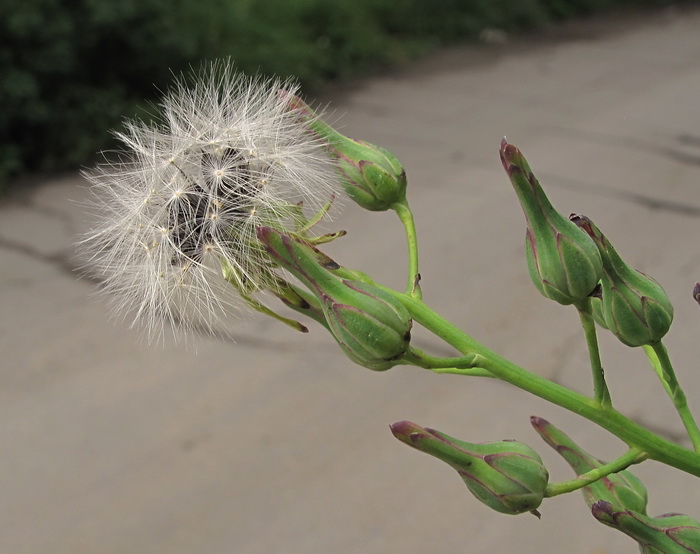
[571,214,673,346]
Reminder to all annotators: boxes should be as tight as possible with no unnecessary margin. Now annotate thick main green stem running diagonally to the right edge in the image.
[384,289,700,477]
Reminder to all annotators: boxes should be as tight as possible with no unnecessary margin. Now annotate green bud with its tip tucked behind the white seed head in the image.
[287,94,406,211]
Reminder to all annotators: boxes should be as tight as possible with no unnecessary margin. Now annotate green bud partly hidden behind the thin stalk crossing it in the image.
[530,417,647,514]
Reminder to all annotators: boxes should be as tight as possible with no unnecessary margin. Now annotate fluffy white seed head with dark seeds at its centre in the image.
[81,63,337,340]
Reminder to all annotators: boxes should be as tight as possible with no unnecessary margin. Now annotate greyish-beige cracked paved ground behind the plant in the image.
[0,5,700,554]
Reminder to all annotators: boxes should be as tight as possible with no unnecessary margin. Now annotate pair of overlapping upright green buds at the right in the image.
[500,139,676,346]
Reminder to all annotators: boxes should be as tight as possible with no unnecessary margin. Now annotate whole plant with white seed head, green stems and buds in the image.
[80,62,700,553]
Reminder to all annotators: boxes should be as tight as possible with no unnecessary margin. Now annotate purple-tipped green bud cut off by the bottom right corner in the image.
[591,500,700,554]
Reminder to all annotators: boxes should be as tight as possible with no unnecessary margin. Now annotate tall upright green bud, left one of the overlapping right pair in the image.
[500,139,603,305]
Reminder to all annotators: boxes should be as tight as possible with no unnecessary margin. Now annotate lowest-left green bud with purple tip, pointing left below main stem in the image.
[391,421,549,515]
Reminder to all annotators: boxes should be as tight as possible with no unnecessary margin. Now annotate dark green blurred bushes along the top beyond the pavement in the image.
[0,0,688,192]
